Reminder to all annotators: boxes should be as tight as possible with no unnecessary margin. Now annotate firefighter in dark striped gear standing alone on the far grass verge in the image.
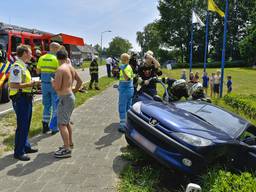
[89,55,100,90]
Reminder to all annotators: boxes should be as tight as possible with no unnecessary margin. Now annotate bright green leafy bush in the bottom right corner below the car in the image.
[202,169,256,192]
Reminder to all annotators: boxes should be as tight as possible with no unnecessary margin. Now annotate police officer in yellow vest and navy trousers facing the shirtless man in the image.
[9,45,38,161]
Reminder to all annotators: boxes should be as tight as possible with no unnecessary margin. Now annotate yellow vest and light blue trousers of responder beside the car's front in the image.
[118,64,134,132]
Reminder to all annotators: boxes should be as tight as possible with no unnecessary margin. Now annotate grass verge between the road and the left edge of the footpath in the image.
[0,77,115,155]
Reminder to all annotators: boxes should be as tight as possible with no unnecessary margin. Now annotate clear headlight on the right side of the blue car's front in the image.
[173,133,212,147]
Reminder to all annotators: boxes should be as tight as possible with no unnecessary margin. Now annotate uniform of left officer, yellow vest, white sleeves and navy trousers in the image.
[9,59,33,158]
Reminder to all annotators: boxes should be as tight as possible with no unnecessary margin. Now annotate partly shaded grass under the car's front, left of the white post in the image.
[118,146,187,192]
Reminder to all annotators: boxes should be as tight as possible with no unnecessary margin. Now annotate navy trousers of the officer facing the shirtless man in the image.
[12,94,33,156]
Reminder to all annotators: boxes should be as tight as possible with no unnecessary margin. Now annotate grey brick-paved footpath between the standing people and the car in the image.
[0,87,126,192]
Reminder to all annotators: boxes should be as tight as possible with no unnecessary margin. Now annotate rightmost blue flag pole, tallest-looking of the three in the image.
[220,0,228,98]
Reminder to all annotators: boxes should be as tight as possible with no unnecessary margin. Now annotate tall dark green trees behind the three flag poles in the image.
[158,0,256,62]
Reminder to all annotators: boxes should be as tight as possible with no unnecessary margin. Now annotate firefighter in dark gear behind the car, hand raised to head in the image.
[138,51,162,96]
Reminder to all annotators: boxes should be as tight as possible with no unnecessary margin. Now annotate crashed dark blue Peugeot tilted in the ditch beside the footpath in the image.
[125,79,256,174]
